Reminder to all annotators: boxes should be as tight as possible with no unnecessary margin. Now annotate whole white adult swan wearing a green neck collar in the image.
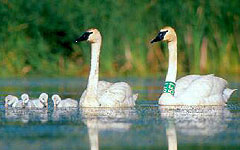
[151,27,236,105]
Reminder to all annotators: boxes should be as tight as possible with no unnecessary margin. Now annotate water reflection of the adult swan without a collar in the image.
[80,108,138,150]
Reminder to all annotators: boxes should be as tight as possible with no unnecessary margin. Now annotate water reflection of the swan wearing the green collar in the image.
[159,106,231,150]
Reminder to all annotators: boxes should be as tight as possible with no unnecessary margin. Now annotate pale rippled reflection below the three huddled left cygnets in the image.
[5,107,48,123]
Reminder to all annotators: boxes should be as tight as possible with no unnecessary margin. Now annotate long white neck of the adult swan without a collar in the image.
[87,41,101,98]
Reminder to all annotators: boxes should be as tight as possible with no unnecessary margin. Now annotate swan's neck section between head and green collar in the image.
[165,40,177,83]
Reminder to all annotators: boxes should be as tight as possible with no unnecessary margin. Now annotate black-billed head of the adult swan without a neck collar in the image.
[76,29,102,43]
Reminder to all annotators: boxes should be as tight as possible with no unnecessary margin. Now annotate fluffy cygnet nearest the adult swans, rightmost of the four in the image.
[52,94,78,108]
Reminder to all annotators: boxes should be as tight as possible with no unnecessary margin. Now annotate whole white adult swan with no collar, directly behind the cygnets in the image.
[76,29,138,107]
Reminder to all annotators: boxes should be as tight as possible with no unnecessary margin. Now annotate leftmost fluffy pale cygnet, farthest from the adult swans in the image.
[5,95,24,108]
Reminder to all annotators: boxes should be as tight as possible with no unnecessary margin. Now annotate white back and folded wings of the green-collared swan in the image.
[175,74,233,105]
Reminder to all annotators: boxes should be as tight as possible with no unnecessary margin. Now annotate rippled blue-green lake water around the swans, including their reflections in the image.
[0,78,240,150]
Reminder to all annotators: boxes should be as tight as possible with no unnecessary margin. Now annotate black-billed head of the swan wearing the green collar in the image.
[151,27,177,43]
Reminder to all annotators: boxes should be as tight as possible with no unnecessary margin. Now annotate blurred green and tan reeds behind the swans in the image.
[0,0,240,77]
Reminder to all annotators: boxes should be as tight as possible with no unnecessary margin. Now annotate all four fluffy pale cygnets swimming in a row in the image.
[5,93,78,108]
